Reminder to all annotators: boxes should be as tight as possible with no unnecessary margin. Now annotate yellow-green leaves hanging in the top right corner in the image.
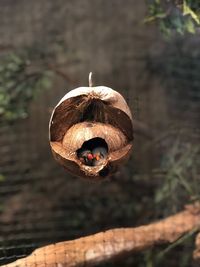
[145,0,200,37]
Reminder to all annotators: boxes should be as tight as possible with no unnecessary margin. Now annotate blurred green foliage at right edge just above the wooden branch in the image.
[155,139,200,203]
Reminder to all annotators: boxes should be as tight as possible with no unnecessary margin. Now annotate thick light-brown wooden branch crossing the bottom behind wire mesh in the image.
[3,204,200,267]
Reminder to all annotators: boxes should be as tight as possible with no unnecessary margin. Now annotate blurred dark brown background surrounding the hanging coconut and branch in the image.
[0,0,200,267]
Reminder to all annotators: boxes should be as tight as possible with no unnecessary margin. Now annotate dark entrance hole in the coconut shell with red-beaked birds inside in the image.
[76,137,108,166]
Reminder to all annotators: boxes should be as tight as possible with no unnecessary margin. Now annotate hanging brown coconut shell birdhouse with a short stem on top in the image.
[49,73,133,178]
